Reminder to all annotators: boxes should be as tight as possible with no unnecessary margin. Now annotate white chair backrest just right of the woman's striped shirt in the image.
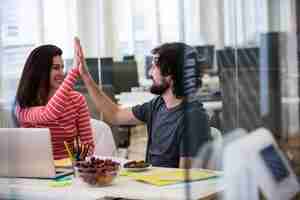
[91,119,117,156]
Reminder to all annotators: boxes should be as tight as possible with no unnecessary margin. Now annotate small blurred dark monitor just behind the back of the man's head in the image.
[195,45,215,72]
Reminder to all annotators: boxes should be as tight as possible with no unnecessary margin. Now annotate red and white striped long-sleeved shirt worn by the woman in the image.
[16,68,94,160]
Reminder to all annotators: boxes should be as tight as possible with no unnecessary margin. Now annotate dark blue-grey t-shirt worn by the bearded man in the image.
[132,97,210,167]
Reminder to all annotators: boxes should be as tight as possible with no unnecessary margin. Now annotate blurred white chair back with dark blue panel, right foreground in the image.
[223,128,300,200]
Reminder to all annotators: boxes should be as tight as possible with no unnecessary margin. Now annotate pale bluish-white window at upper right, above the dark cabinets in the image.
[224,0,268,46]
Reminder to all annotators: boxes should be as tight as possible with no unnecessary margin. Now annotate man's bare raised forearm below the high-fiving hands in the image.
[82,76,118,124]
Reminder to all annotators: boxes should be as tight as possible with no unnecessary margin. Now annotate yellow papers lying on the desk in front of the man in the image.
[121,169,219,186]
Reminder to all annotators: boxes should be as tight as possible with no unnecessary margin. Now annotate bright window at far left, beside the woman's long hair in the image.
[0,0,40,102]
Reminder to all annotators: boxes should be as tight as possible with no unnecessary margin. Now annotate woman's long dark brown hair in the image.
[16,45,62,108]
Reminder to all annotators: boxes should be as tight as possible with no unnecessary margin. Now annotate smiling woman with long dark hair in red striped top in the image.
[15,40,94,160]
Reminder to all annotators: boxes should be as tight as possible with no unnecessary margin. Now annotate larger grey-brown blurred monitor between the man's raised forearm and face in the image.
[113,61,139,94]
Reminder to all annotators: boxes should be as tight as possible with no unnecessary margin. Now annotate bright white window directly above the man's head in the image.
[114,0,180,55]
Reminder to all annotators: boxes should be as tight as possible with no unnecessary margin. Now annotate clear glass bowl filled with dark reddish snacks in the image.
[75,157,120,186]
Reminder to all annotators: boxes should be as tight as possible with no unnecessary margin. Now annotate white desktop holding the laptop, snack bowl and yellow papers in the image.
[0,168,223,200]
